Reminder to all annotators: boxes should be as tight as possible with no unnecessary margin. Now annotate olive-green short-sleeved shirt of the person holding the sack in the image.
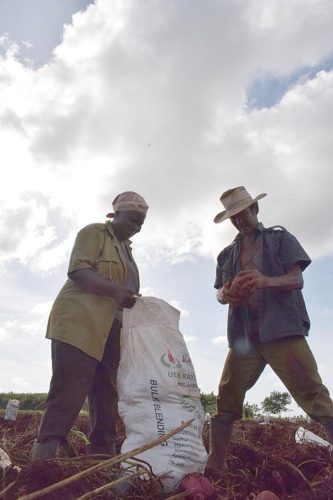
[46,222,136,361]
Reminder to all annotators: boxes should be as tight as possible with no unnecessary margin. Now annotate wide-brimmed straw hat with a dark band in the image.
[214,186,267,224]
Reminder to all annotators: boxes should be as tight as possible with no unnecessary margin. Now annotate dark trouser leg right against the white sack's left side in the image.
[88,320,121,454]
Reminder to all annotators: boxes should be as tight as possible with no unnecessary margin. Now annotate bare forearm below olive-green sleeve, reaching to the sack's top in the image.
[68,268,135,308]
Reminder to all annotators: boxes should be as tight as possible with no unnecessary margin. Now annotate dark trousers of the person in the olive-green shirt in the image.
[38,320,121,446]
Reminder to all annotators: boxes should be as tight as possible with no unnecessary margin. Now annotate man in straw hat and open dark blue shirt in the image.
[206,186,333,472]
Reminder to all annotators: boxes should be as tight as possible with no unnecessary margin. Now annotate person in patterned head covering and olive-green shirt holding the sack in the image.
[32,191,148,461]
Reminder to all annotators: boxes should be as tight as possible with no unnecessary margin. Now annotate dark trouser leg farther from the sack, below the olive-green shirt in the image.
[38,340,98,443]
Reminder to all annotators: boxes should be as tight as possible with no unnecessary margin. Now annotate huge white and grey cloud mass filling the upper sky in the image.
[0,0,333,272]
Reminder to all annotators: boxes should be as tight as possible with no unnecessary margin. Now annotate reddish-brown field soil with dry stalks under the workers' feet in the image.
[0,412,333,500]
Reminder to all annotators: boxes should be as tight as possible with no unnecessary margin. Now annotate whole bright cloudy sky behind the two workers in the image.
[0,0,333,414]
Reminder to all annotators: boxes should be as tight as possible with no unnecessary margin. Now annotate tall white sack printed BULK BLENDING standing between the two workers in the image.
[118,297,207,490]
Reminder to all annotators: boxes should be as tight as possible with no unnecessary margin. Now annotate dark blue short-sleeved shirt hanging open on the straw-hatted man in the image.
[214,223,311,351]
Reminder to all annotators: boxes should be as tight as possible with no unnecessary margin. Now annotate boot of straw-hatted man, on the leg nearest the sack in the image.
[205,416,234,475]
